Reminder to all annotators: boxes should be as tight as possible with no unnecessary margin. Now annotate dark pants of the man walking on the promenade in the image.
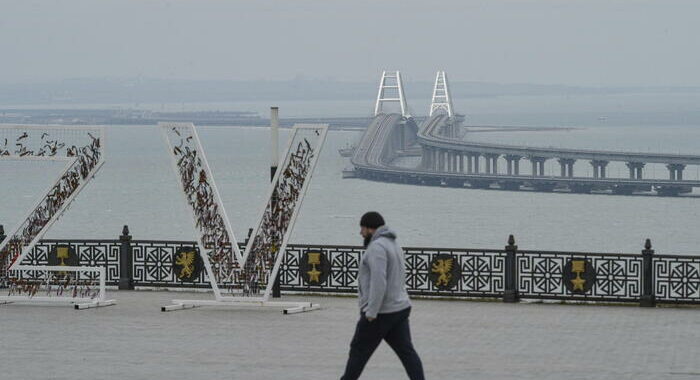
[341,307,425,380]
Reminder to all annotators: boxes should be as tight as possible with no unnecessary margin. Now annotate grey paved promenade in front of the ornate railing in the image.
[0,291,700,380]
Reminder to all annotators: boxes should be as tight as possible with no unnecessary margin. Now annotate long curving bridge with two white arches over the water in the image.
[351,71,700,196]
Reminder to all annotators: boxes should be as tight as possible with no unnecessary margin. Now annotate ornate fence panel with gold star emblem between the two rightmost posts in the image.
[516,251,642,302]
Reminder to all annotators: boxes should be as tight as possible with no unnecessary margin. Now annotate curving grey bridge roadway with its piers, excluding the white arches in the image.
[351,114,700,196]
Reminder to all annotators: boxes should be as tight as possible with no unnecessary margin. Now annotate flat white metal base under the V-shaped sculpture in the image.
[160,297,321,314]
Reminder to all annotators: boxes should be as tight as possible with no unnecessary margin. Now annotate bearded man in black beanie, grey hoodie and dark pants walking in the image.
[341,211,425,380]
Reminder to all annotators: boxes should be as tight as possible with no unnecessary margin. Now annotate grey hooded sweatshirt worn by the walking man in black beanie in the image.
[358,226,411,318]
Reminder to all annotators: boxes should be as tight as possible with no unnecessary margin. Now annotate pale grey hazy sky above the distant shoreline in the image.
[0,0,700,86]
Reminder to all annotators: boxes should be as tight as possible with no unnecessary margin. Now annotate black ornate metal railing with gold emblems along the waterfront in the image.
[0,226,700,306]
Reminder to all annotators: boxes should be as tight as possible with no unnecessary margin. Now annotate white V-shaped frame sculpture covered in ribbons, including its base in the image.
[159,123,328,314]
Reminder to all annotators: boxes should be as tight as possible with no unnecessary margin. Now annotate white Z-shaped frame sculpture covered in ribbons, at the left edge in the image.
[0,125,114,309]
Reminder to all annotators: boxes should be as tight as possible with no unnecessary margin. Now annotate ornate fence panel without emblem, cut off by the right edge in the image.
[653,255,700,303]
